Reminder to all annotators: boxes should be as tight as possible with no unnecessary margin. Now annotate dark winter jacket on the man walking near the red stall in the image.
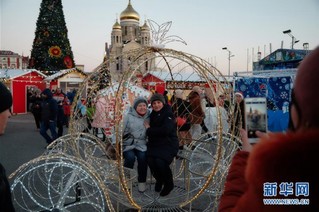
[41,89,58,123]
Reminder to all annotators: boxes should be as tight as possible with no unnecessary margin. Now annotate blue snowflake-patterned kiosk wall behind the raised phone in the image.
[234,69,297,132]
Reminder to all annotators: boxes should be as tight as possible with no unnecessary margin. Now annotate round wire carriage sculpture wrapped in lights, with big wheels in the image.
[11,47,238,211]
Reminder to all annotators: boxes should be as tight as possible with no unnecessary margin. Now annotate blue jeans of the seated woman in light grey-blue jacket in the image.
[123,149,147,183]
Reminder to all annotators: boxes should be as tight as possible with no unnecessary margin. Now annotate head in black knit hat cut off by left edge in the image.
[0,82,12,136]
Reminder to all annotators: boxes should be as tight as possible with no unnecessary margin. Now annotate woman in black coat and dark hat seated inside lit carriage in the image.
[144,94,178,196]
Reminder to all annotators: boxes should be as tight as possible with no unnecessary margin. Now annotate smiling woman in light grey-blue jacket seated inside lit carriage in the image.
[123,97,150,192]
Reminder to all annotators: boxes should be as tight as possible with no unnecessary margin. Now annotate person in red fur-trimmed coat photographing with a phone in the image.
[219,47,319,212]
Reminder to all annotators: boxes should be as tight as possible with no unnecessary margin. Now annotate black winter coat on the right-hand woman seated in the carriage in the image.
[146,104,178,163]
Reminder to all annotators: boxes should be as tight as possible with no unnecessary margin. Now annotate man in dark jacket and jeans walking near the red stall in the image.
[40,89,58,144]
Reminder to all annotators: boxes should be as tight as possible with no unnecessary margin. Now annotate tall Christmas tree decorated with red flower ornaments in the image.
[29,0,74,75]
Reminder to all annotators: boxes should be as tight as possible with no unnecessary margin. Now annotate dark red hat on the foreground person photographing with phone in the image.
[294,47,319,128]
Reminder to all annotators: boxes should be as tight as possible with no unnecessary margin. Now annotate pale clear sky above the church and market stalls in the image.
[0,0,319,74]
